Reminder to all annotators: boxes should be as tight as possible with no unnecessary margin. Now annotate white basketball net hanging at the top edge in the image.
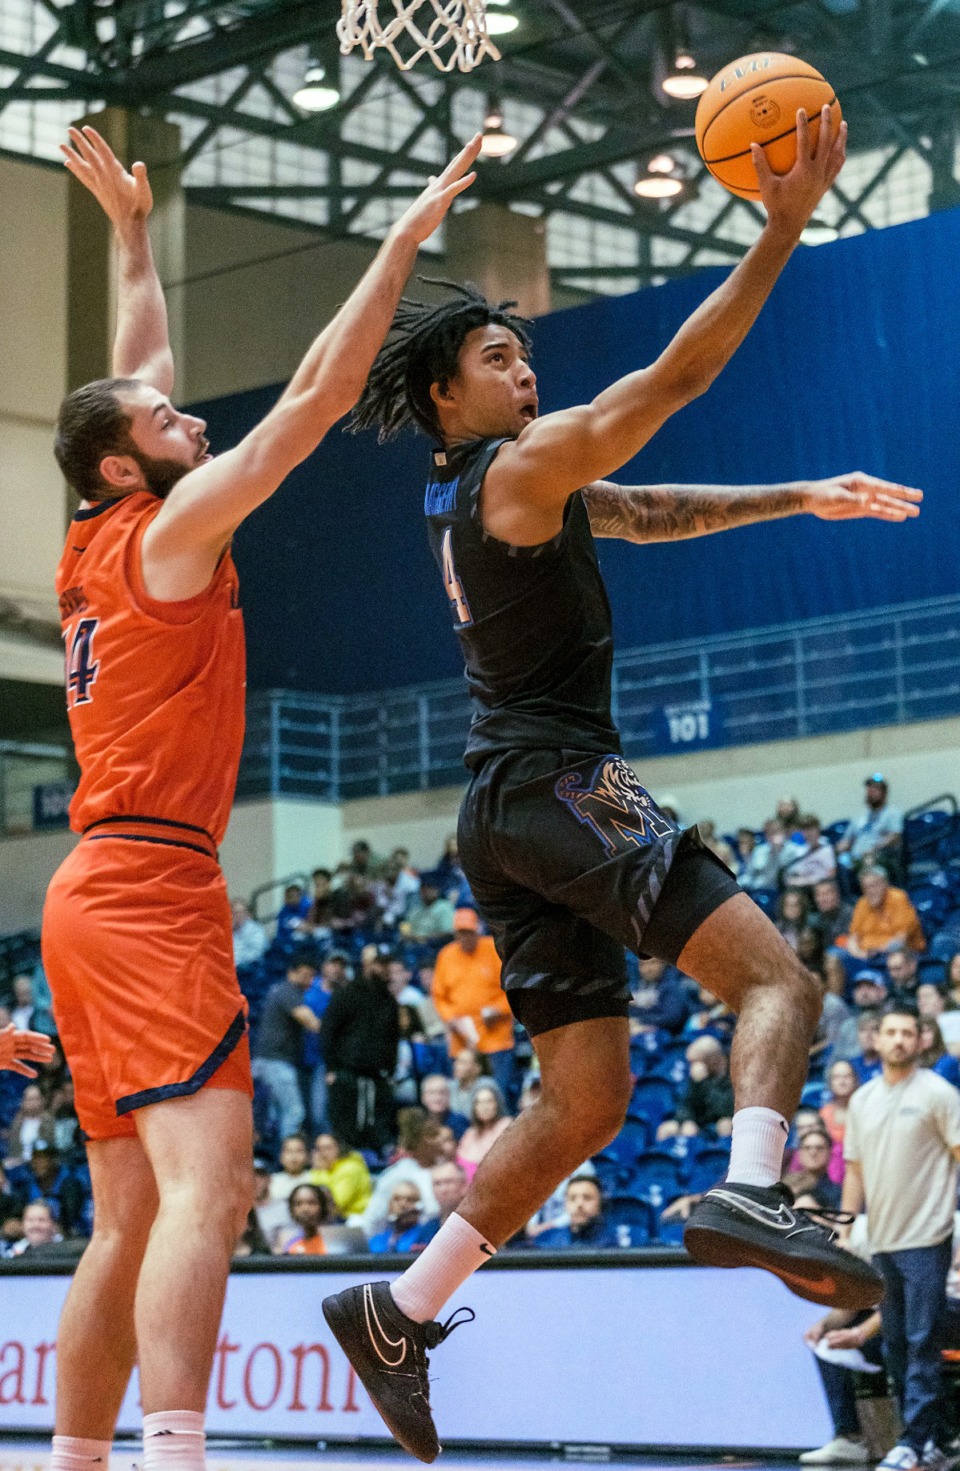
[337,0,500,72]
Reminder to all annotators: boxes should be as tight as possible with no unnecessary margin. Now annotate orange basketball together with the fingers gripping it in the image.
[695,51,847,214]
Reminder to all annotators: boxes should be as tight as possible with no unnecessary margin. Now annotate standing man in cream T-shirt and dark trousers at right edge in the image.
[842,1002,960,1471]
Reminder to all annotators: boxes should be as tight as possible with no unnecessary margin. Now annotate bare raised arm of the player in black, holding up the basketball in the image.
[485,109,847,520]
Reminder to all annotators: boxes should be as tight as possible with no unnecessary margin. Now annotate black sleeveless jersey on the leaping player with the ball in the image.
[423,440,620,768]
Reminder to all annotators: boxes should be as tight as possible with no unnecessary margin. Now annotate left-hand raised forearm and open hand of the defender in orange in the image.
[60,128,173,394]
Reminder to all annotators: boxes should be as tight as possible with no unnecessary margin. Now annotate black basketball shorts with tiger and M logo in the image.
[457,750,741,1036]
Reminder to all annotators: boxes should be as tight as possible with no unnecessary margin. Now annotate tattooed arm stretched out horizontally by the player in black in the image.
[584,471,923,541]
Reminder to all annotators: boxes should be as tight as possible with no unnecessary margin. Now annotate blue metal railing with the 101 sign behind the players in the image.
[238,596,960,802]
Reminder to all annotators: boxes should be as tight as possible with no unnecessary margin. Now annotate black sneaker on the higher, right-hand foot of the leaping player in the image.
[684,1183,884,1311]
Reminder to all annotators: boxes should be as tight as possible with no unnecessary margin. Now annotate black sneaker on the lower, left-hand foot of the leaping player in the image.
[323,1283,475,1461]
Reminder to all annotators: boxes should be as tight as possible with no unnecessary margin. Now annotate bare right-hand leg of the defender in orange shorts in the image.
[135,1087,253,1412]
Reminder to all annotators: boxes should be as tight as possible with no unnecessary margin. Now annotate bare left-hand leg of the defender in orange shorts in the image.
[51,1137,157,1447]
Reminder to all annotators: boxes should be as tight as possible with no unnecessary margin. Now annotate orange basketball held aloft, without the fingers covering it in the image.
[697,51,842,199]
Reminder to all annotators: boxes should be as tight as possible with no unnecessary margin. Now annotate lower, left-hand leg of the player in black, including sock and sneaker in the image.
[323,991,632,1461]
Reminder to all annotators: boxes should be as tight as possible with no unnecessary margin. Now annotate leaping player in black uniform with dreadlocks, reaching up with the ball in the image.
[323,110,920,1461]
